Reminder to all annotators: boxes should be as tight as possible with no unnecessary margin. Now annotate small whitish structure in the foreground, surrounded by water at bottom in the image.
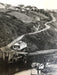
[31,62,44,75]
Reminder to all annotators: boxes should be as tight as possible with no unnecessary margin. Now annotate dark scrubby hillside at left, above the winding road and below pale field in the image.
[0,13,34,47]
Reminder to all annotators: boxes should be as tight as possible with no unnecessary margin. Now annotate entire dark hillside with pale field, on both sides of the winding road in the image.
[0,2,57,51]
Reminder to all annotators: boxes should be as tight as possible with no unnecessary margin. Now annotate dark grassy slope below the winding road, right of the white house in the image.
[23,12,57,51]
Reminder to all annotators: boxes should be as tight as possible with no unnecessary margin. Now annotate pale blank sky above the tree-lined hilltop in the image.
[0,0,57,9]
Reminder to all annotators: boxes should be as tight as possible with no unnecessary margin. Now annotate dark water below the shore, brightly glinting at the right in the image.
[0,53,57,75]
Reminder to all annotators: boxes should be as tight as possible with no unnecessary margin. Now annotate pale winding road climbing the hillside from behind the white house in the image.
[0,13,56,53]
